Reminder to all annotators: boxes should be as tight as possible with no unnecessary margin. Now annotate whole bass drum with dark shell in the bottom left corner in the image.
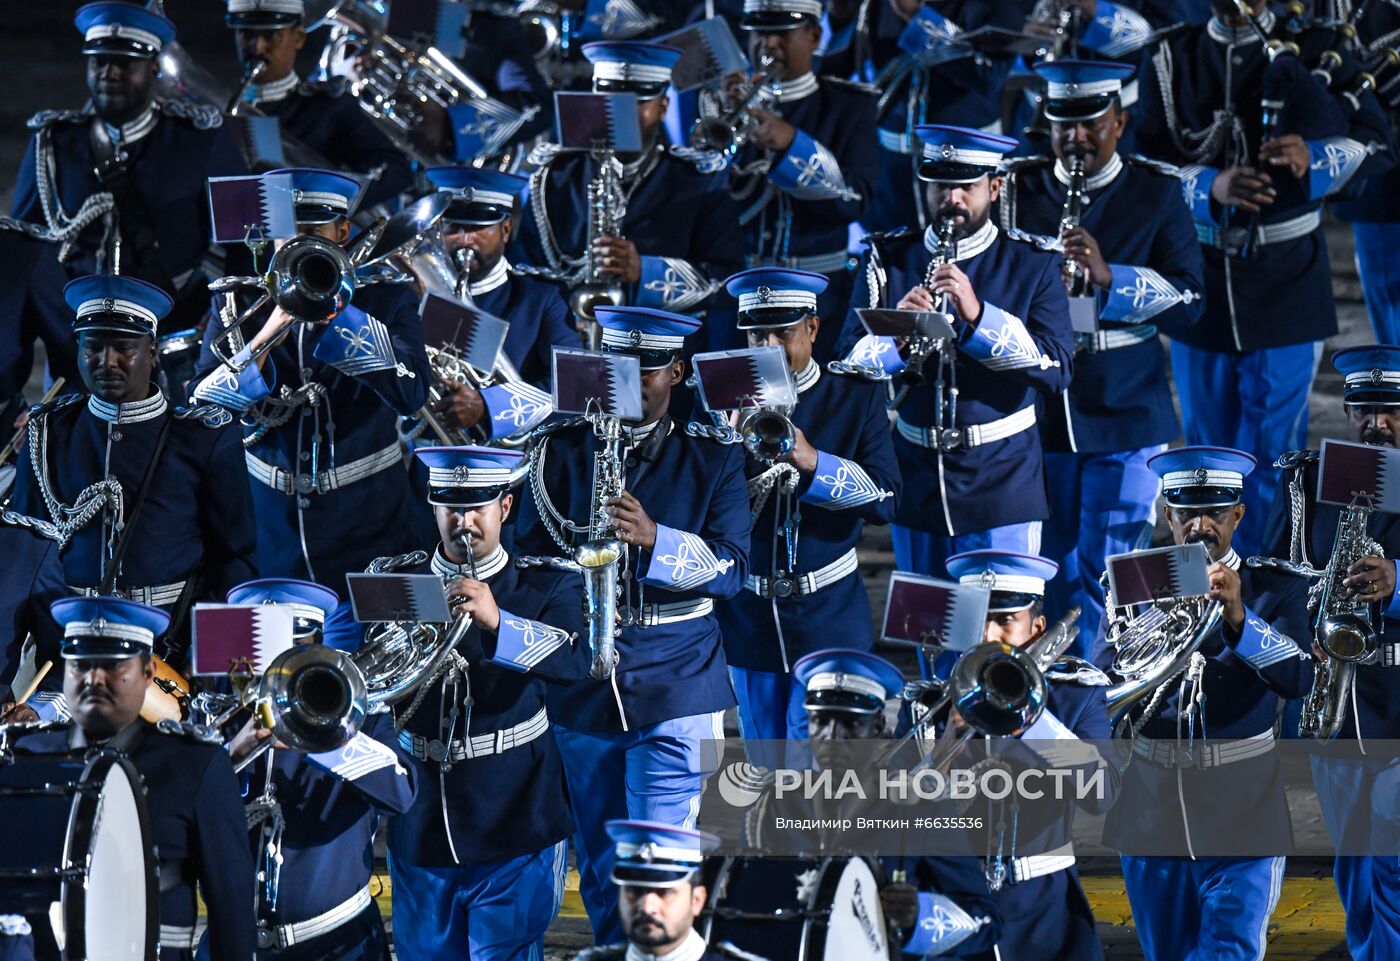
[0,751,160,961]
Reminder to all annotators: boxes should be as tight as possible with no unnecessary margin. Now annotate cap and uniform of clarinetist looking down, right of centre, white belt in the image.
[844,127,1074,574]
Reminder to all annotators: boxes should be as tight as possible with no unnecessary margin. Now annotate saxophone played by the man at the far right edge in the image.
[1246,451,1385,741]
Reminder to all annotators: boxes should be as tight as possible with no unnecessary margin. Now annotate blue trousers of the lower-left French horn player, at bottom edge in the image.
[389,841,568,961]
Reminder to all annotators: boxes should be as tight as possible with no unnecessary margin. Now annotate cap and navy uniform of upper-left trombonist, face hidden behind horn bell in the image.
[192,168,430,649]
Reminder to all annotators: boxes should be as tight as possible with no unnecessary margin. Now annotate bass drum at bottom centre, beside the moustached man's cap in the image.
[699,857,899,961]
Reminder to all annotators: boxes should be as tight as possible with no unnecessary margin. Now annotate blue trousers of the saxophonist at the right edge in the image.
[1312,756,1400,961]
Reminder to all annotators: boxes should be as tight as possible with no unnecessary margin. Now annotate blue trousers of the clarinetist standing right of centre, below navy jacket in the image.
[1040,444,1166,657]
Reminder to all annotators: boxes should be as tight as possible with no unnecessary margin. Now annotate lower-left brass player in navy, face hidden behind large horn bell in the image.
[228,579,417,961]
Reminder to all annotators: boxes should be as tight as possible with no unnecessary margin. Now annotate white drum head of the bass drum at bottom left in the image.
[63,754,158,961]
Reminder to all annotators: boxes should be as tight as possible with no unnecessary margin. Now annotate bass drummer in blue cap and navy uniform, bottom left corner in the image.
[2,597,255,961]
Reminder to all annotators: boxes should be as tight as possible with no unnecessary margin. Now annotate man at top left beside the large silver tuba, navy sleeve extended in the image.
[225,0,413,207]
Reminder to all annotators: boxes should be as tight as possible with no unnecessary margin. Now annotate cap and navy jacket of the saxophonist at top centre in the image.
[519,42,743,323]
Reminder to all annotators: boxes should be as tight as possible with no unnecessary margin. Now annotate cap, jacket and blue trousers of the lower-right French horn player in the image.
[1103,447,1312,961]
